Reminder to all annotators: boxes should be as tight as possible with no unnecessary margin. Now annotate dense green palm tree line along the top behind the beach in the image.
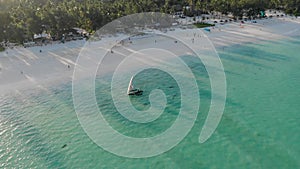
[0,0,300,43]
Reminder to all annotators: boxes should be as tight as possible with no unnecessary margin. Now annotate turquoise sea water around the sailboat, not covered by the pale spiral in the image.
[0,38,300,169]
